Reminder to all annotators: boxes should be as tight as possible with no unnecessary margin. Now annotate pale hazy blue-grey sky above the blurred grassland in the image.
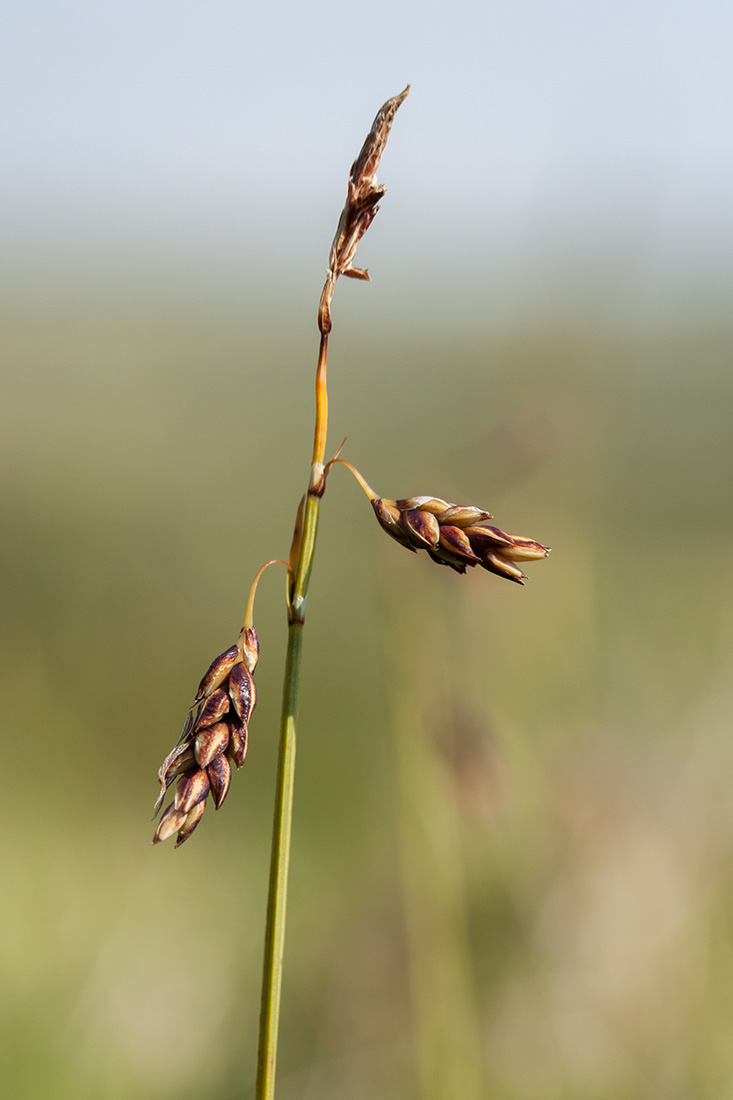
[0,0,733,314]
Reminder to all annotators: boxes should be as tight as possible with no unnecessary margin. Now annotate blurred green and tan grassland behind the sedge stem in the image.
[0,294,733,1100]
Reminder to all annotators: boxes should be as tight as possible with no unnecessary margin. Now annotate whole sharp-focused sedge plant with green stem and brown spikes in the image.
[153,85,549,1100]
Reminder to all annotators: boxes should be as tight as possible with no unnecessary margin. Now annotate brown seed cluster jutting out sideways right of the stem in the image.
[372,496,550,584]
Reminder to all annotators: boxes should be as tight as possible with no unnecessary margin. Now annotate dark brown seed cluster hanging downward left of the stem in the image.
[153,627,260,848]
